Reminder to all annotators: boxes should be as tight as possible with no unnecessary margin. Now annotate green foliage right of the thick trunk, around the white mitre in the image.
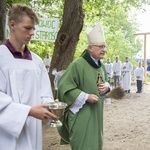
[75,0,149,66]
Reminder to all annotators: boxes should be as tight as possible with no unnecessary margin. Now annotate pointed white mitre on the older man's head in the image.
[86,22,105,45]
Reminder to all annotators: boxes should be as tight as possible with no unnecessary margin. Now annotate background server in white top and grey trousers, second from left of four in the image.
[113,56,122,87]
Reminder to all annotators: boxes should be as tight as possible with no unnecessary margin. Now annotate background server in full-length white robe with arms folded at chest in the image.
[121,57,133,93]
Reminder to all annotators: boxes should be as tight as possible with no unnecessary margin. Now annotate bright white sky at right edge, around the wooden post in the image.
[137,5,150,58]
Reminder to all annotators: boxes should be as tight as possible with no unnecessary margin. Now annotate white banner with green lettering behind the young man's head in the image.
[5,17,59,42]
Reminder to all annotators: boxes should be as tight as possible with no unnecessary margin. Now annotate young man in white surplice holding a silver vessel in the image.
[0,4,57,150]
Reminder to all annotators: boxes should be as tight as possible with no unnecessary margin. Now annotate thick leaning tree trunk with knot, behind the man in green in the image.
[49,0,84,97]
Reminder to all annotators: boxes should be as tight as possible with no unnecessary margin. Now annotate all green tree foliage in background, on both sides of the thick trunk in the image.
[2,0,150,62]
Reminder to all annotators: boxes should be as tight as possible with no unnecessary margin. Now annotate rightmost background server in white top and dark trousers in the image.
[134,62,144,93]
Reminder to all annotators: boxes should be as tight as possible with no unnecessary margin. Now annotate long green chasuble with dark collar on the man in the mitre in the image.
[57,50,107,150]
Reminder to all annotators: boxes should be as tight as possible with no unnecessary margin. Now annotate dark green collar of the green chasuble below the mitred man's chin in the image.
[81,50,101,68]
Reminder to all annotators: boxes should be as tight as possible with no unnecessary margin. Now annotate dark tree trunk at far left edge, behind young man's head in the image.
[0,0,6,44]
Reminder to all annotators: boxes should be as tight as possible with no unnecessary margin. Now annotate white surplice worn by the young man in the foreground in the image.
[0,45,53,150]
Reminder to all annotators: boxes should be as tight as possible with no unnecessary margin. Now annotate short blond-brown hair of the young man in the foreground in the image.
[8,3,39,24]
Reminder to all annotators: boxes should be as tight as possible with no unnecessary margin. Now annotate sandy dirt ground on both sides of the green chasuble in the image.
[43,84,150,150]
